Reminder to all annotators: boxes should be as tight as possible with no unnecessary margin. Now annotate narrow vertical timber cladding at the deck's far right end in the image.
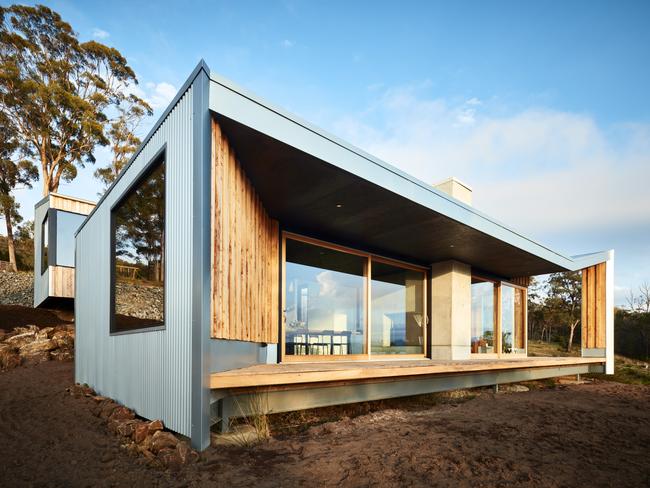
[582,263,606,349]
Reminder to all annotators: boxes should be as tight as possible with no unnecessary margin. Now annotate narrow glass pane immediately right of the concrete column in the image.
[471,278,496,354]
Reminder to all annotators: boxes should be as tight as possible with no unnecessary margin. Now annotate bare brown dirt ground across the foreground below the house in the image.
[0,361,650,487]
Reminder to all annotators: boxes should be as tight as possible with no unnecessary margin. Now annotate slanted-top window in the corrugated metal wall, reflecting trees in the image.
[113,162,165,332]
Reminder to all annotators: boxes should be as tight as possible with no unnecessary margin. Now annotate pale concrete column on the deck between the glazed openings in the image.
[430,261,472,359]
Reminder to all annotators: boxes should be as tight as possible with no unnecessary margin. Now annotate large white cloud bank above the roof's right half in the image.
[333,86,650,236]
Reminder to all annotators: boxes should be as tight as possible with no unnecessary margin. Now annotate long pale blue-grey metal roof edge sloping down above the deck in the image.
[209,68,572,269]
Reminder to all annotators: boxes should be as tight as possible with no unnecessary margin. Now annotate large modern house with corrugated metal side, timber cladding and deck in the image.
[75,62,614,449]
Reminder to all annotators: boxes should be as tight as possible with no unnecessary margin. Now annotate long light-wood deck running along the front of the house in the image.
[210,357,605,389]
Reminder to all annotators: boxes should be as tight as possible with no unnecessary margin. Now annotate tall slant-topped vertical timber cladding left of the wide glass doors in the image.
[211,120,279,343]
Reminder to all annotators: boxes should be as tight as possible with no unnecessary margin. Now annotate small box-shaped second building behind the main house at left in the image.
[34,193,95,307]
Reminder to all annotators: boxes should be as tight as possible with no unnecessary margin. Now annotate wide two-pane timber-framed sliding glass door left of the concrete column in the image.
[284,236,426,359]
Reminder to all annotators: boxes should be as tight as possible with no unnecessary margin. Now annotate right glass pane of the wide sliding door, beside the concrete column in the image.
[370,261,425,354]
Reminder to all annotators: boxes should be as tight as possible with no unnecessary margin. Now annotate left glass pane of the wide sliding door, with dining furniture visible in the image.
[285,239,367,356]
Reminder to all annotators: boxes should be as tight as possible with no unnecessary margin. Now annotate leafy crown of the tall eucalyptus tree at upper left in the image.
[0,5,146,195]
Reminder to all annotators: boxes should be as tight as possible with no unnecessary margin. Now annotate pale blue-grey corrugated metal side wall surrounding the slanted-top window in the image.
[75,86,194,436]
